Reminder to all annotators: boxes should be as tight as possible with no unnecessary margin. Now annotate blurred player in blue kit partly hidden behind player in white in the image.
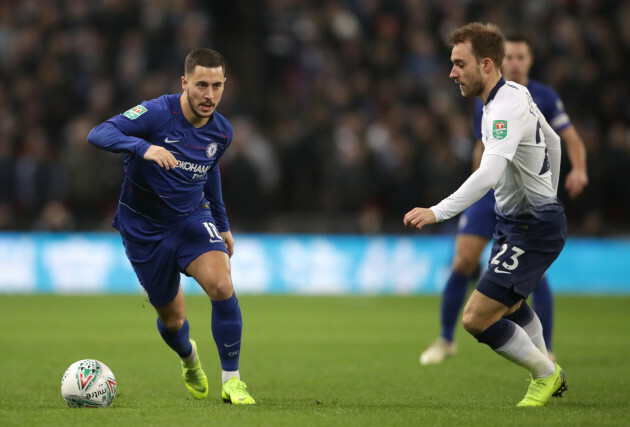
[420,35,588,365]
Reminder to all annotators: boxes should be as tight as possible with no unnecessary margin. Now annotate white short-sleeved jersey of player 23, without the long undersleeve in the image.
[481,78,560,216]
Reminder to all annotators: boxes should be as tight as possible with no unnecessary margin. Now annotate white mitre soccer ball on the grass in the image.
[61,359,116,408]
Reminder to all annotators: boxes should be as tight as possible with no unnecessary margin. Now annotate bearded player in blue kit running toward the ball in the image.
[88,49,255,404]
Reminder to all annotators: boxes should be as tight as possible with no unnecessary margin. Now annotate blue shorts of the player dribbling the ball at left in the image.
[122,208,227,307]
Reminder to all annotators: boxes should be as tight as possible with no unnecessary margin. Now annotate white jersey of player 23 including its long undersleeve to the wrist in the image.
[431,77,560,222]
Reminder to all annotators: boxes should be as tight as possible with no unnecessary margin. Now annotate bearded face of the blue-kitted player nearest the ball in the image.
[182,65,225,120]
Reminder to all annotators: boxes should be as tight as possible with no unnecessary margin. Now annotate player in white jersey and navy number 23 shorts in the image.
[403,23,567,407]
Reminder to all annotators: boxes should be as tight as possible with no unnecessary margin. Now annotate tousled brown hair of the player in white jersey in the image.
[449,22,505,67]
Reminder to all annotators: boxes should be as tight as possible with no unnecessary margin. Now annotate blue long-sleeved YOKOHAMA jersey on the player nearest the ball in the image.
[88,95,234,239]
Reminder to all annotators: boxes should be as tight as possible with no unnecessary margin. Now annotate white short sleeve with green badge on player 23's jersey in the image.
[484,102,529,161]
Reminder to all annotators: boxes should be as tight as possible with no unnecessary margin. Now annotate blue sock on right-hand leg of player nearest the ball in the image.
[211,294,243,371]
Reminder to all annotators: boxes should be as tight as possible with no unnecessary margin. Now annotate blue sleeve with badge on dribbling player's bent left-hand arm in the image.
[88,101,161,157]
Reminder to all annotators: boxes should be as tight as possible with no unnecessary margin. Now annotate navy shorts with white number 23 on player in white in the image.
[477,202,567,307]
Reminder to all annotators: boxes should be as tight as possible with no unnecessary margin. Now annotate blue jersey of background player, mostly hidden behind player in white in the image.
[474,79,571,139]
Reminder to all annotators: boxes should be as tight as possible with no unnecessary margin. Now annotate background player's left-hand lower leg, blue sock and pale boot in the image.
[420,234,489,365]
